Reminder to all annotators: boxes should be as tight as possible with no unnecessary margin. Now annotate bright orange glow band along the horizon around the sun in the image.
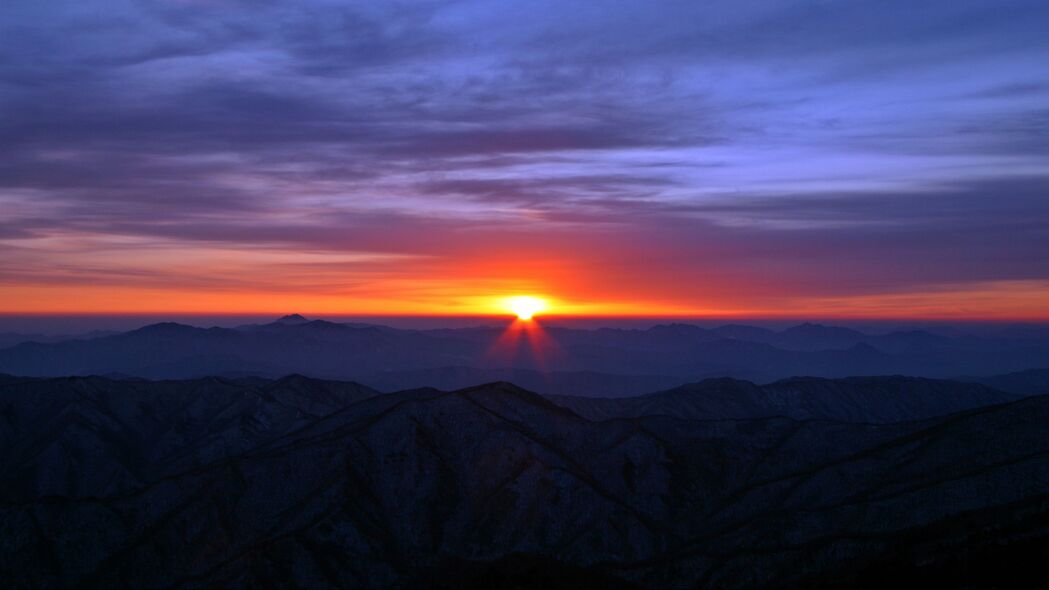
[0,278,1049,321]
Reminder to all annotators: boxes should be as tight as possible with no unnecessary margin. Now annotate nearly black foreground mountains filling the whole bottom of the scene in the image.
[0,377,1049,588]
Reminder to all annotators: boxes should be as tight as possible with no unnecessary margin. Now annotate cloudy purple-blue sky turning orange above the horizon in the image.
[0,0,1049,320]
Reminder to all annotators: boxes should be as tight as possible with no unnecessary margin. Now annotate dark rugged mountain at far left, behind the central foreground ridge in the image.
[0,376,378,496]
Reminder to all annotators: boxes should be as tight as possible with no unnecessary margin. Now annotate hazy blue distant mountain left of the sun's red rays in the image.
[0,320,481,378]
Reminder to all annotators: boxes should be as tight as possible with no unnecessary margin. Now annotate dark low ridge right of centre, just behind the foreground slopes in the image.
[551,376,1020,423]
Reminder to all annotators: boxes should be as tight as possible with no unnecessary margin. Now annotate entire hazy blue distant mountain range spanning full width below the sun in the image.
[0,316,1049,390]
